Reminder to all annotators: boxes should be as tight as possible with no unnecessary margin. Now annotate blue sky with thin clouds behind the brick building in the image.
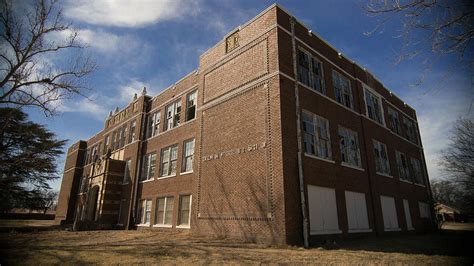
[24,0,474,189]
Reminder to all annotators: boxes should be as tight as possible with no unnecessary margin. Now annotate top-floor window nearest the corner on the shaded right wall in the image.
[298,50,326,94]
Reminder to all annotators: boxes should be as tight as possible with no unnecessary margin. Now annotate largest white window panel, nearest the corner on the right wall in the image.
[308,186,341,235]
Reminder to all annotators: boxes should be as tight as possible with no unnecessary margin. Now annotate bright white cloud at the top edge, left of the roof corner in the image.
[65,0,199,27]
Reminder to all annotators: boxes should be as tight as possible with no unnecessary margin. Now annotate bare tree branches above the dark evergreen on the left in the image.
[0,0,95,115]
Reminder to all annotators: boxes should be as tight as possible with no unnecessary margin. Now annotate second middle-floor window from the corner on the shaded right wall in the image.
[339,126,362,167]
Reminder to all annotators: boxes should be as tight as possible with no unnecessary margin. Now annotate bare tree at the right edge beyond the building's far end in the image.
[441,119,474,212]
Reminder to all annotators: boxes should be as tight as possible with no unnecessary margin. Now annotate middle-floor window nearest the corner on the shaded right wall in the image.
[303,112,332,159]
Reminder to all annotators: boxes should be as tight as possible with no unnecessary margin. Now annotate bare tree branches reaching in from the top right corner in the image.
[365,0,474,82]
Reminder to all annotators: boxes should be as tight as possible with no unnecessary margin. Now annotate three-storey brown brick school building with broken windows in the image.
[56,4,433,245]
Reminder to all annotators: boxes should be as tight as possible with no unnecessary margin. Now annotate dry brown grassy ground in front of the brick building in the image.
[0,222,474,265]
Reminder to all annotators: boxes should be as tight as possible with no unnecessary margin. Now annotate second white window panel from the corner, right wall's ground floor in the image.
[345,191,370,232]
